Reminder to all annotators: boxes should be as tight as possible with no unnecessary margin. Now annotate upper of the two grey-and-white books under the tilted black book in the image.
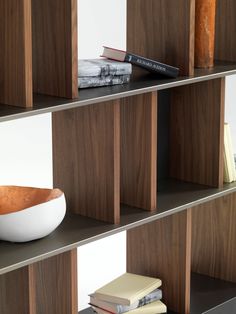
[78,59,132,77]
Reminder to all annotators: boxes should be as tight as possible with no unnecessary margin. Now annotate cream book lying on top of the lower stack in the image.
[94,273,161,305]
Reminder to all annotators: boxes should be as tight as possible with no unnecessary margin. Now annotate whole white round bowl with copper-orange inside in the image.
[0,186,66,242]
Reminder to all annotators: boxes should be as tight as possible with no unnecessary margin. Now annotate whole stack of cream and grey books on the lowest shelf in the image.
[90,273,167,314]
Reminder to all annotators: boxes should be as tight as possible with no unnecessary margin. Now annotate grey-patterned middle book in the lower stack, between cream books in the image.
[90,289,162,314]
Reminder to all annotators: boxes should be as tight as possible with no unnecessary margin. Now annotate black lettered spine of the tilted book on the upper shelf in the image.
[125,53,179,78]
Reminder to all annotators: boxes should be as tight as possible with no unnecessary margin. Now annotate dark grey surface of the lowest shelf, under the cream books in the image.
[79,273,236,314]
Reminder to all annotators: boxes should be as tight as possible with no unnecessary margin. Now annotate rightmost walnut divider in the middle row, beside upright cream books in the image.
[170,79,225,187]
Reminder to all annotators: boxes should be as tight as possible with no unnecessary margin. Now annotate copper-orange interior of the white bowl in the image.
[0,186,63,215]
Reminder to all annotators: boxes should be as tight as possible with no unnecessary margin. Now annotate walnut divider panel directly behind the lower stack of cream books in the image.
[127,210,191,313]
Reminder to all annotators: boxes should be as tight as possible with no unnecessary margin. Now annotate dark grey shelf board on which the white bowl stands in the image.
[0,180,236,275]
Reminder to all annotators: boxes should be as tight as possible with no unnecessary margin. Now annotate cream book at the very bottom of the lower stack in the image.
[93,301,167,314]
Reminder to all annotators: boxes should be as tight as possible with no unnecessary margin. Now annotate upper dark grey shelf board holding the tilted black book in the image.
[0,62,236,122]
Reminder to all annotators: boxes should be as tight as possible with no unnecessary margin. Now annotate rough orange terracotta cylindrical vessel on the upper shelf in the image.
[195,0,216,68]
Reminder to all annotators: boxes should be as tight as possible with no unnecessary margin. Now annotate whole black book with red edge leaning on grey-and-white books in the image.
[102,47,179,78]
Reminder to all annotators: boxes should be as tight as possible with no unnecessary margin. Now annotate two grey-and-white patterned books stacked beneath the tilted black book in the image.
[78,59,132,88]
